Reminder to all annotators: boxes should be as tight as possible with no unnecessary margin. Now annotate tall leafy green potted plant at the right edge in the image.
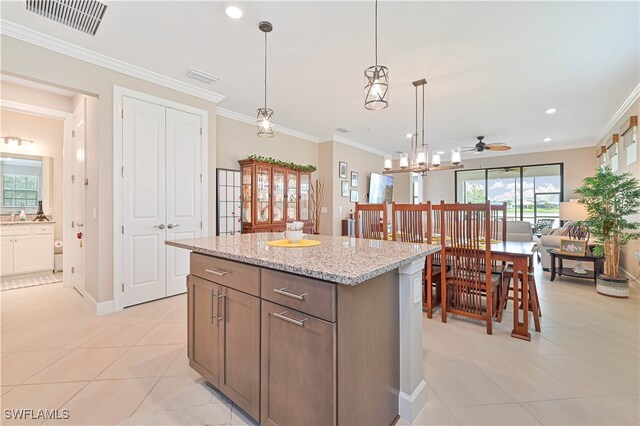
[576,167,640,297]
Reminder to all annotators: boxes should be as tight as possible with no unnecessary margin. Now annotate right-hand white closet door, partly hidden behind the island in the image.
[166,108,202,296]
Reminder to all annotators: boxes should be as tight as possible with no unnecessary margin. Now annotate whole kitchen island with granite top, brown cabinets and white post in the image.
[166,233,439,425]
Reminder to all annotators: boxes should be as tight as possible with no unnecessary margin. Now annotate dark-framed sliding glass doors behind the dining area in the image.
[455,164,564,223]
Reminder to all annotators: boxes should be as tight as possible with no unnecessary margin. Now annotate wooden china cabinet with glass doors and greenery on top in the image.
[239,160,312,233]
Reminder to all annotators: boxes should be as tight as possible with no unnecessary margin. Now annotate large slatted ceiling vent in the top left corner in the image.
[27,0,107,35]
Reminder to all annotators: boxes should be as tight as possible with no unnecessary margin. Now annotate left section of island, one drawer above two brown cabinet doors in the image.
[187,254,260,419]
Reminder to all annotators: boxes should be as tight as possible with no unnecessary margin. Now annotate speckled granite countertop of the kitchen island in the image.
[165,232,440,285]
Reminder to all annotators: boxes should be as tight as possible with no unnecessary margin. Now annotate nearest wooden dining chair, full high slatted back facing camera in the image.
[440,202,501,334]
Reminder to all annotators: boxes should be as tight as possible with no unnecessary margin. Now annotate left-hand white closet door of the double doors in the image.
[122,96,167,307]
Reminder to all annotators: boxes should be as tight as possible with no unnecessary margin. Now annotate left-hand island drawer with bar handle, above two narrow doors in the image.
[191,253,260,297]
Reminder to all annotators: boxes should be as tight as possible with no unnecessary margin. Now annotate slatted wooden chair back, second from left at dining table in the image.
[391,202,431,243]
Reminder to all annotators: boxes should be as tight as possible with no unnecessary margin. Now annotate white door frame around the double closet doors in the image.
[113,85,209,312]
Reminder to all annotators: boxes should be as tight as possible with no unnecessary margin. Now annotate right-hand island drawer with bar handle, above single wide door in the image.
[261,269,336,322]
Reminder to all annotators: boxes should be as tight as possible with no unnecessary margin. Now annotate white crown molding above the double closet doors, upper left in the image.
[0,19,224,103]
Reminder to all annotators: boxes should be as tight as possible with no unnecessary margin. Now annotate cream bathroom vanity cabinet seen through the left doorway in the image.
[0,223,53,276]
